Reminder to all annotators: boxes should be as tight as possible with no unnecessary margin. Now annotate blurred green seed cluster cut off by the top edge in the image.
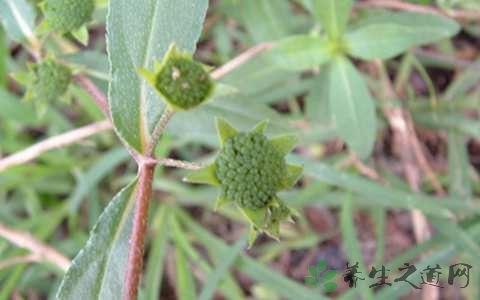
[44,0,95,32]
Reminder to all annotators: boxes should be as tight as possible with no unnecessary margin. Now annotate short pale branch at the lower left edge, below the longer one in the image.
[0,223,70,271]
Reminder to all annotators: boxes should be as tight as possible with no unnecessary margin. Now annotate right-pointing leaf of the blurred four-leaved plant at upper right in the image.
[346,12,460,59]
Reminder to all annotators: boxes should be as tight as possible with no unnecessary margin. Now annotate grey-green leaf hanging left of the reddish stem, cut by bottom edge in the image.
[57,180,137,299]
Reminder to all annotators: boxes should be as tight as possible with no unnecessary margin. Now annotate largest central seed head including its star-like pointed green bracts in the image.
[186,119,303,244]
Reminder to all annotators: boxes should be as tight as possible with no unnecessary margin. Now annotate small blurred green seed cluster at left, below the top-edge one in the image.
[30,59,71,101]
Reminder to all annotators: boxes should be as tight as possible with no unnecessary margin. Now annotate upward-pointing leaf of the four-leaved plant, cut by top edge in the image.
[314,0,353,38]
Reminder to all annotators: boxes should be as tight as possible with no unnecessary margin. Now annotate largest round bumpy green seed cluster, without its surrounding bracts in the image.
[216,132,286,209]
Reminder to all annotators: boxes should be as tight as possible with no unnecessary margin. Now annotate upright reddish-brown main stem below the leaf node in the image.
[123,163,155,300]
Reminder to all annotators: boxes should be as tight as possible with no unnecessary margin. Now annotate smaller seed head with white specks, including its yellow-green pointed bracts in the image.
[139,45,214,110]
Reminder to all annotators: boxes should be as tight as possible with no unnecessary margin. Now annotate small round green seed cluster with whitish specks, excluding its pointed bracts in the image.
[155,57,213,109]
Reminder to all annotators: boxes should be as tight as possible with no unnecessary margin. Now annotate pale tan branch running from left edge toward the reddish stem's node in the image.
[0,120,112,172]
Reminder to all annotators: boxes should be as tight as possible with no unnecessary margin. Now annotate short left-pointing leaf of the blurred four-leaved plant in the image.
[269,35,331,71]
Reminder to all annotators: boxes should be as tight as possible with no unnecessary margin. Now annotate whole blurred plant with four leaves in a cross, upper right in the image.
[273,0,459,158]
